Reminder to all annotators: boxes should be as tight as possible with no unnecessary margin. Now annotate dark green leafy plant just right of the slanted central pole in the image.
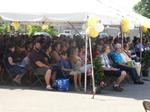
[93,57,104,85]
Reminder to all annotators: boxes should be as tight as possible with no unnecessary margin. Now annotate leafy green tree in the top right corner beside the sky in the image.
[134,0,150,18]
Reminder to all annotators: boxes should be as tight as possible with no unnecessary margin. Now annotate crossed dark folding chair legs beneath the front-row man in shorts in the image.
[30,66,45,88]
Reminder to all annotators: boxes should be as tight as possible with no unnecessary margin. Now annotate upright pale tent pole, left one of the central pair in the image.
[84,36,88,93]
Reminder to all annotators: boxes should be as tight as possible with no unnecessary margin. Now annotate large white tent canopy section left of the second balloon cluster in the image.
[0,0,120,25]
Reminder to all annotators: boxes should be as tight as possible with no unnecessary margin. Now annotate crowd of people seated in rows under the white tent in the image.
[0,35,149,91]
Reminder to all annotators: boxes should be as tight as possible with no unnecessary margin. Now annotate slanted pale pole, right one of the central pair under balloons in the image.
[89,38,96,99]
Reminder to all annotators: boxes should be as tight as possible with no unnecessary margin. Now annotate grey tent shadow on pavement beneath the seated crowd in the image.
[0,77,150,100]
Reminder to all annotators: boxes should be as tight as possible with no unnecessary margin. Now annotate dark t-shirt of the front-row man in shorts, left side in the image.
[29,49,47,68]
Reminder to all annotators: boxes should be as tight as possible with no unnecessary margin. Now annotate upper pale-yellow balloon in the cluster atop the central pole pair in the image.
[87,16,99,27]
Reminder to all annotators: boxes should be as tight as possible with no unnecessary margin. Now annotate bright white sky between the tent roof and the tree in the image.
[102,0,140,11]
